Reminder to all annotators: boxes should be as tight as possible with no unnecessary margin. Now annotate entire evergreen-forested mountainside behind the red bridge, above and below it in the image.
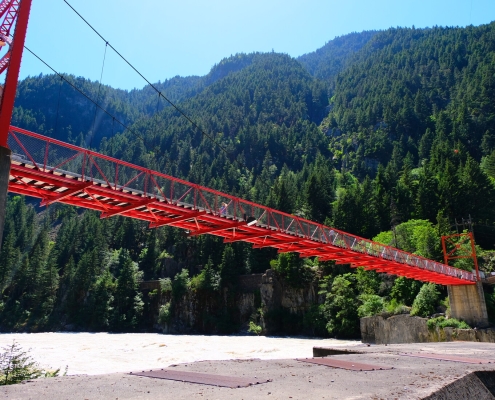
[0,23,495,335]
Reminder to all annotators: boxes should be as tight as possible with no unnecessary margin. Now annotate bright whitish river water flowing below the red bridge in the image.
[0,332,360,375]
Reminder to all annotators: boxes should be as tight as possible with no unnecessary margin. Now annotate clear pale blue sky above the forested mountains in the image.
[14,0,495,89]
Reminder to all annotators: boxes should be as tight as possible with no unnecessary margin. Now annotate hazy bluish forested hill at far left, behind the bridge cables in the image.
[12,74,205,148]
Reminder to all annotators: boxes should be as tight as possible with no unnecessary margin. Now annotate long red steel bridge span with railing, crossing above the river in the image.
[8,126,476,285]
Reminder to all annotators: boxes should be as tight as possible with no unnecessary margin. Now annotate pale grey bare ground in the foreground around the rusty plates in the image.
[0,342,495,400]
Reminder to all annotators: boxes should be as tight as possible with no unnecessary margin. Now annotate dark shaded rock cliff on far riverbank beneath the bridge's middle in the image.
[154,270,324,334]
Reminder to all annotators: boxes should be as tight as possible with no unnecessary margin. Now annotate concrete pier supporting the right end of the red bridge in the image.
[447,281,488,328]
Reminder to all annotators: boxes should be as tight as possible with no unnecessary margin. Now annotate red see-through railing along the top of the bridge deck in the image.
[8,126,476,281]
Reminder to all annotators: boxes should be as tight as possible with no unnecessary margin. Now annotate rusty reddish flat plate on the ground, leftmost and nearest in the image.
[130,369,271,388]
